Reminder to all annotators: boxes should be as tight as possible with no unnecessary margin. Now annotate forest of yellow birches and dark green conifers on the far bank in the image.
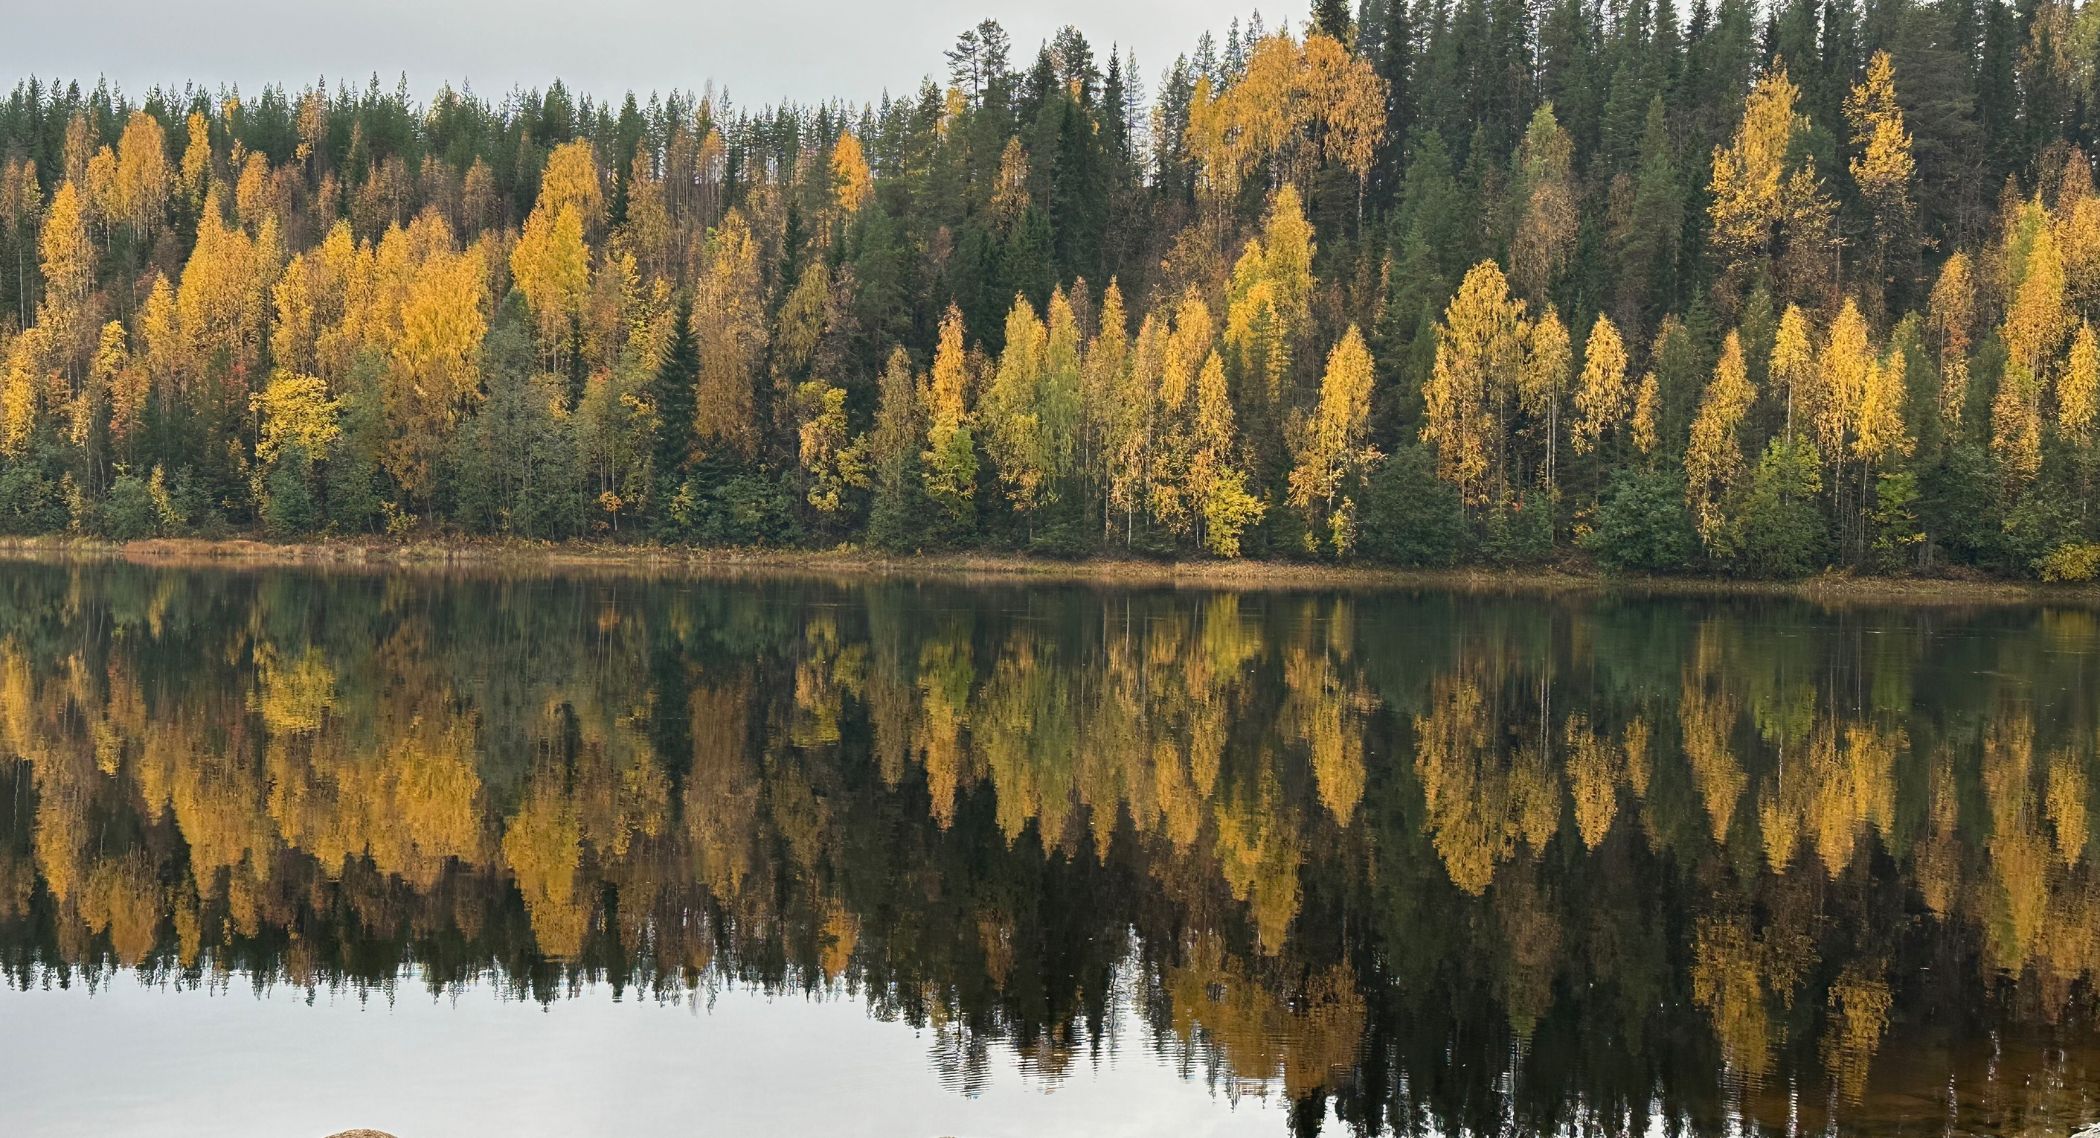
[0,0,2100,582]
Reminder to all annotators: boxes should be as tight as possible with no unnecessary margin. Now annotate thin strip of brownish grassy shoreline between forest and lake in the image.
[0,535,2100,607]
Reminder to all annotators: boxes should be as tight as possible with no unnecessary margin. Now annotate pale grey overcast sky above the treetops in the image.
[0,0,1260,105]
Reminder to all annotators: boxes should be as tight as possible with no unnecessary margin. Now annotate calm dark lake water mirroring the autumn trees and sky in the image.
[0,565,2100,1138]
